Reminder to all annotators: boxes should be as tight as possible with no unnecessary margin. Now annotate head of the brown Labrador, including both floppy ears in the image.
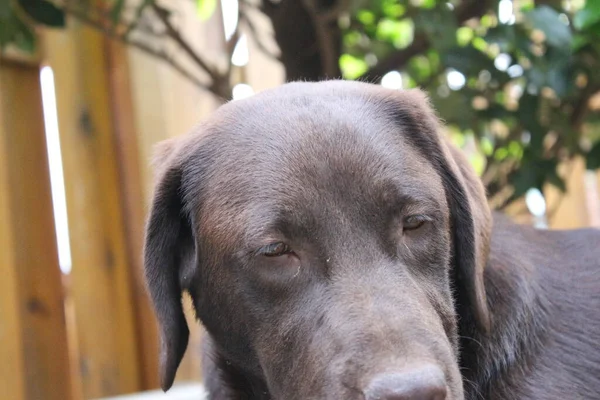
[145,81,490,399]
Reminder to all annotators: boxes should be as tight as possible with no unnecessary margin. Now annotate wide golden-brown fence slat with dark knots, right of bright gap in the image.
[45,20,142,399]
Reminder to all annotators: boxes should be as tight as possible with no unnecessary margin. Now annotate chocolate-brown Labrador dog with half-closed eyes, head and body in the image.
[145,81,600,400]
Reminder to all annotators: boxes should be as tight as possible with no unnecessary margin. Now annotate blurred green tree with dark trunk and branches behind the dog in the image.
[0,0,600,207]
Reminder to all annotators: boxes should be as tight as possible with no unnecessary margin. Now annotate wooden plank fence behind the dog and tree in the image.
[0,6,598,400]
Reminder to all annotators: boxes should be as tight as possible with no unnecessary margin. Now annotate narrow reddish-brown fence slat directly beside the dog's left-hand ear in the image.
[106,41,160,390]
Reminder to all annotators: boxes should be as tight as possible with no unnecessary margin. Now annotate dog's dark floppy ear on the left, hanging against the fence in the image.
[144,140,196,391]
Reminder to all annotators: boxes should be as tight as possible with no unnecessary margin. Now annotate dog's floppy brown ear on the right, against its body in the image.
[384,89,492,332]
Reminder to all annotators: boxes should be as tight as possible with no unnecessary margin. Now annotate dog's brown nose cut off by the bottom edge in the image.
[364,365,447,400]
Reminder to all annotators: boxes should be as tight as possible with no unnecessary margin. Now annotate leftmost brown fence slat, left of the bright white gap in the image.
[0,64,72,400]
